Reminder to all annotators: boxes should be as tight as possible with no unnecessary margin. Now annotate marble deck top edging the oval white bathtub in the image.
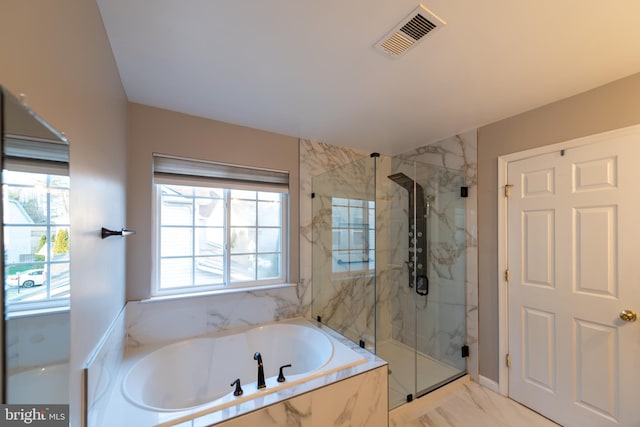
[102,319,386,427]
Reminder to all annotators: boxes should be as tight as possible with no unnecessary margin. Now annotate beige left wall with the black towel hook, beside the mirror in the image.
[0,0,127,426]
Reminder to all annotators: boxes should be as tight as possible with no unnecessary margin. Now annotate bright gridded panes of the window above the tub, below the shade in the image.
[154,183,287,295]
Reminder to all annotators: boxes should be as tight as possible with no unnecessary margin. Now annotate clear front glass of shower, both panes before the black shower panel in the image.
[376,158,466,408]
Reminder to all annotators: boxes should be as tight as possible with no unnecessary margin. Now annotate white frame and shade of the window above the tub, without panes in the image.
[151,153,290,298]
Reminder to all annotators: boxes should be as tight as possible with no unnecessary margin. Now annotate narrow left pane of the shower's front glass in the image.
[376,157,423,408]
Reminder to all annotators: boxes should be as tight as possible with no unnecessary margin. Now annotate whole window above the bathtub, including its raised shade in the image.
[153,155,288,295]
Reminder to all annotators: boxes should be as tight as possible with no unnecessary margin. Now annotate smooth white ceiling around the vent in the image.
[97,0,640,154]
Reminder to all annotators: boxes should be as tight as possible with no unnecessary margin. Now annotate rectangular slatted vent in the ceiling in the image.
[375,5,447,58]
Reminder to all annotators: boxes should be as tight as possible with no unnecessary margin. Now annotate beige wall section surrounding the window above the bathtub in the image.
[127,103,299,301]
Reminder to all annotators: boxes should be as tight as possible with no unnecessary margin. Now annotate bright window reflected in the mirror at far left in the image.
[2,171,70,312]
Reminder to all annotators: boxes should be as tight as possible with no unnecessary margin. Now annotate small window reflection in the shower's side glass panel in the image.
[331,197,375,273]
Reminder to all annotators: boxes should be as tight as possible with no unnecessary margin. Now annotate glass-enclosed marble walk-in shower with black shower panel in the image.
[312,155,466,408]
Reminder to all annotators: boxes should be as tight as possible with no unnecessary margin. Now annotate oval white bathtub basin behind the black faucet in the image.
[122,319,366,413]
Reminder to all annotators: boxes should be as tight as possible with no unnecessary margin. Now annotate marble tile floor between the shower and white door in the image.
[389,376,558,427]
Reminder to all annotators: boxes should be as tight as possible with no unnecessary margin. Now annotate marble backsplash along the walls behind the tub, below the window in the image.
[83,292,300,426]
